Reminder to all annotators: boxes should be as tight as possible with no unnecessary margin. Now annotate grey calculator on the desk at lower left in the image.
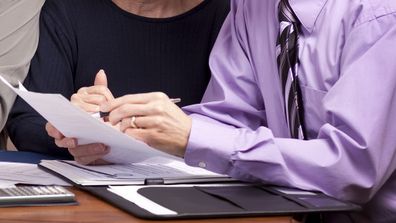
[0,186,76,207]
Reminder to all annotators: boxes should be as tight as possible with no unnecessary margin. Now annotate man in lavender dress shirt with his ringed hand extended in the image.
[54,0,396,223]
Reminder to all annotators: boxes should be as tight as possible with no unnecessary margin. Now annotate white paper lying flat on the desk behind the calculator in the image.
[0,162,70,188]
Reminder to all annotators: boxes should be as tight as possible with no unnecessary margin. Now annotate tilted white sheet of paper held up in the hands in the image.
[0,76,175,163]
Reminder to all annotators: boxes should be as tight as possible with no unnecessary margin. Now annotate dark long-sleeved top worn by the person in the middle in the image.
[7,0,229,158]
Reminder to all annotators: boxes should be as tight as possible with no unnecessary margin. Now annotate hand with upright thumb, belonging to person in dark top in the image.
[70,70,114,113]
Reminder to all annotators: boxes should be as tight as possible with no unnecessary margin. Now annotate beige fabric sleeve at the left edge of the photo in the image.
[0,0,45,148]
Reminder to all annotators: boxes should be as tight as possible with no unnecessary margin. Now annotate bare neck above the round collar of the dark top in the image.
[112,0,203,18]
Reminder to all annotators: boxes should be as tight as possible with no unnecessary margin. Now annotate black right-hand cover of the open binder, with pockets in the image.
[83,184,360,219]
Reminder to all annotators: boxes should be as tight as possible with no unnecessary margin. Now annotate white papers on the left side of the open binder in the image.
[39,157,235,186]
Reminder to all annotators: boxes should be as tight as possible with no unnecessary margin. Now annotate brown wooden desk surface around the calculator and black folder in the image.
[0,188,297,223]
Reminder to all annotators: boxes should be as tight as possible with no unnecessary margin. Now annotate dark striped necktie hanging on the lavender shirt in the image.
[277,0,305,139]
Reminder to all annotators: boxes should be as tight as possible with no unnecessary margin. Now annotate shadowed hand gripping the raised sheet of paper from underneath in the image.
[45,123,110,165]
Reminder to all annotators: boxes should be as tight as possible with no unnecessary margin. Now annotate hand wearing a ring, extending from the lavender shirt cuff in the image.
[100,93,192,157]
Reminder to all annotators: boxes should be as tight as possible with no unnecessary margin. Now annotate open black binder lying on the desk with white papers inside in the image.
[39,158,360,219]
